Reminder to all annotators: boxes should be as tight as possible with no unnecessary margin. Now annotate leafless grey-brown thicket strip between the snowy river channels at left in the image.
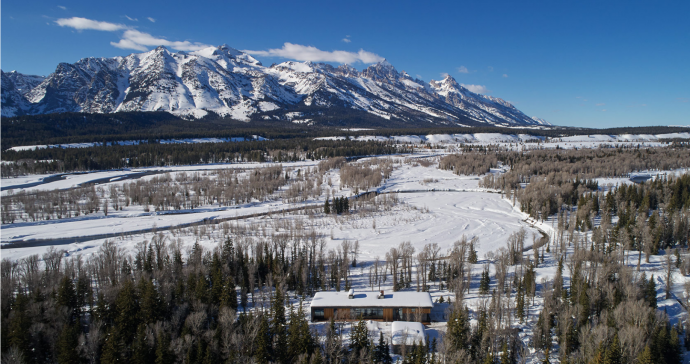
[2,165,286,224]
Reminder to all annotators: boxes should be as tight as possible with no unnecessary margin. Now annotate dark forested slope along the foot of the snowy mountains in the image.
[1,107,690,149]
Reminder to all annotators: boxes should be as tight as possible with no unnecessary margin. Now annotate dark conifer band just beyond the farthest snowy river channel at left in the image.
[2,138,406,177]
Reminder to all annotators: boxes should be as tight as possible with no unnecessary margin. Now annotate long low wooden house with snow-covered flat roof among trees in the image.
[311,289,434,323]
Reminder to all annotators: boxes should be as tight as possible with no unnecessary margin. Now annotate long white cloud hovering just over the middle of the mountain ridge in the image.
[243,42,385,63]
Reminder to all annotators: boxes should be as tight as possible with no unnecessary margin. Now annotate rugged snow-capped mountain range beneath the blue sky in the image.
[2,45,550,126]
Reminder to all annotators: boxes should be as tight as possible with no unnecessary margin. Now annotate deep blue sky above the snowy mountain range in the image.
[1,0,690,128]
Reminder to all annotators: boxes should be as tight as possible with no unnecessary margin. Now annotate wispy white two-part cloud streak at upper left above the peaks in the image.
[55,15,210,52]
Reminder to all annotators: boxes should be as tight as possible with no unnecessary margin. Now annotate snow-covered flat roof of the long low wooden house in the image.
[311,291,434,308]
